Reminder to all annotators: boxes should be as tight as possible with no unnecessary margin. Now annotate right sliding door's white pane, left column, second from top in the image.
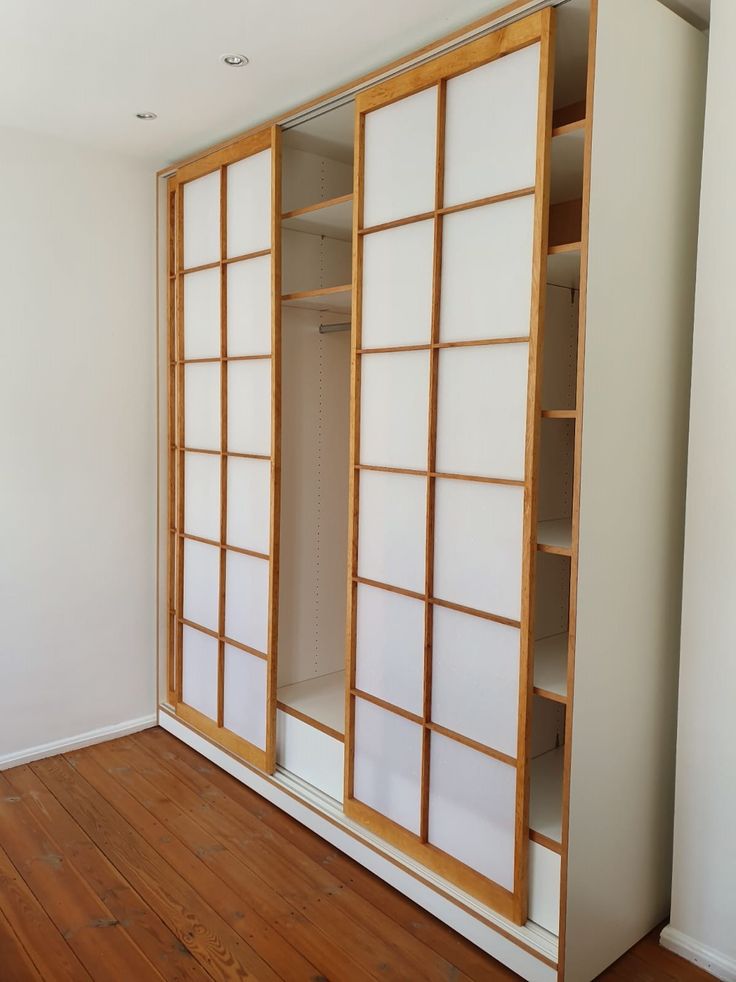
[361,219,434,348]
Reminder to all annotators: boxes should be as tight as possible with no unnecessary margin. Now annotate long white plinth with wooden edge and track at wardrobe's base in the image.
[159,710,557,982]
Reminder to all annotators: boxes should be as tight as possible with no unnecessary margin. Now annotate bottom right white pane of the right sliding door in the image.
[429,733,516,890]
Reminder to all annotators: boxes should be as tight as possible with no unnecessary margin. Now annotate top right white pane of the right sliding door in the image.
[444,43,540,206]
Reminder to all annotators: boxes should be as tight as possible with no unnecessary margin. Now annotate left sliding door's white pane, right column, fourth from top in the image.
[227,457,271,553]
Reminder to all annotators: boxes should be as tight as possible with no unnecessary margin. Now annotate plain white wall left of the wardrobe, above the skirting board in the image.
[0,129,156,766]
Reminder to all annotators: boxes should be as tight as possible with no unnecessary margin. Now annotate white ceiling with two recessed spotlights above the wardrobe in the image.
[0,0,710,166]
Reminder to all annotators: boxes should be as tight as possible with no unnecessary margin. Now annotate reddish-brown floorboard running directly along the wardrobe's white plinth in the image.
[142,728,518,982]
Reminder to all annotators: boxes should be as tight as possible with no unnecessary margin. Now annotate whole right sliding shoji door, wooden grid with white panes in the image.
[345,10,553,922]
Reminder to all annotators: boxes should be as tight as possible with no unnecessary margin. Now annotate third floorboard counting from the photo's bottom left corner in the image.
[0,774,162,982]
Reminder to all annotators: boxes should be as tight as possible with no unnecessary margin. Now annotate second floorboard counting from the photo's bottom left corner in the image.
[0,836,90,982]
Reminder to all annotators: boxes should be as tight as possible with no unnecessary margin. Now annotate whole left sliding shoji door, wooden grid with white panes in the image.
[170,127,281,771]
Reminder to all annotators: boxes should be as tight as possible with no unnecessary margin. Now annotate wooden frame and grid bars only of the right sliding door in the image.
[344,8,554,923]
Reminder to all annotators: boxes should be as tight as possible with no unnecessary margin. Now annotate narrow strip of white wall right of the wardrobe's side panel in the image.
[663,0,736,979]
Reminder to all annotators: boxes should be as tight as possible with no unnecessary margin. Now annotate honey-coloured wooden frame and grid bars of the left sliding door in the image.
[168,125,281,773]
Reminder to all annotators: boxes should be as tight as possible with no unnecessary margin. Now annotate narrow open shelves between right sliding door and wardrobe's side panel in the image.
[529,21,589,900]
